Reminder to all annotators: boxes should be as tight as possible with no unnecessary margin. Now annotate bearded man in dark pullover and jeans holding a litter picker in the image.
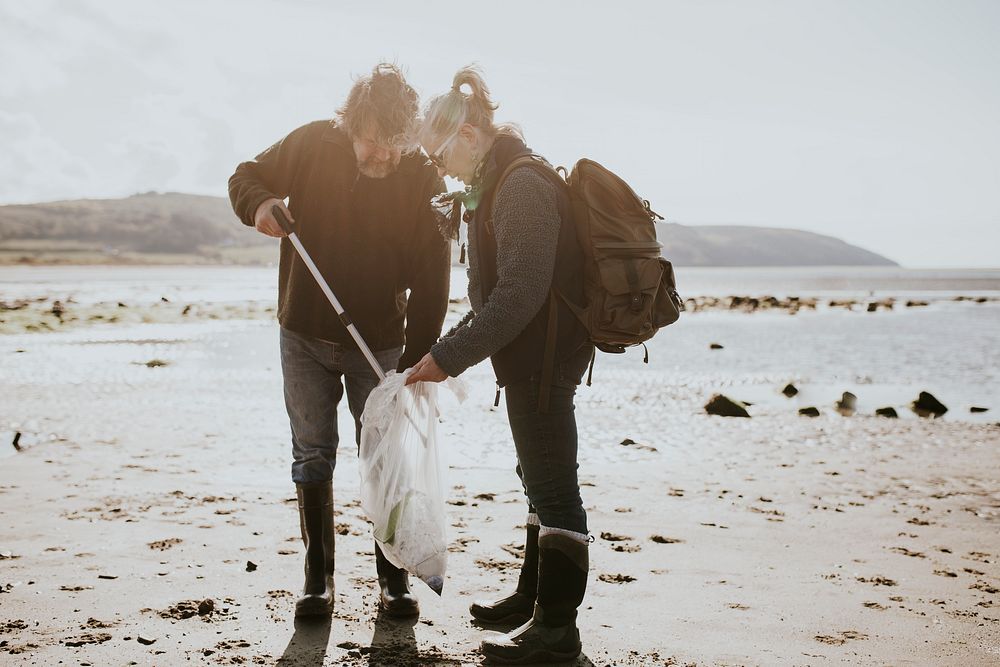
[229,63,450,616]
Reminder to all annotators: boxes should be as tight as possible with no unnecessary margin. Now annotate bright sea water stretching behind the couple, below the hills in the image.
[0,266,1000,456]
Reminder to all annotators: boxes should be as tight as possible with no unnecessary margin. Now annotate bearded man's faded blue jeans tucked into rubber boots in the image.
[281,328,403,484]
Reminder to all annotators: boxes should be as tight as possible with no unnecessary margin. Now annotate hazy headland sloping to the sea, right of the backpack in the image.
[656,223,898,266]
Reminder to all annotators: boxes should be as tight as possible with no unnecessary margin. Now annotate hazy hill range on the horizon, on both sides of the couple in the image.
[0,192,894,266]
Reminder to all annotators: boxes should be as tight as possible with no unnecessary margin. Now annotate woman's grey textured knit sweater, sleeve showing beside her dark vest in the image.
[431,167,560,377]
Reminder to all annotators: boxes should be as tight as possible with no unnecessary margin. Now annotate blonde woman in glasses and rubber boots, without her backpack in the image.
[408,67,593,663]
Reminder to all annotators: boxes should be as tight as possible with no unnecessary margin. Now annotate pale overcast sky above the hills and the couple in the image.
[0,0,1000,267]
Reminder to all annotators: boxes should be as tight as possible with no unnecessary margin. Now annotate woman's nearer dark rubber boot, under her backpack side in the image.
[480,533,589,665]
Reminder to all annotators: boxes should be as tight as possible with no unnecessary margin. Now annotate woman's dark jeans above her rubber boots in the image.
[504,344,594,534]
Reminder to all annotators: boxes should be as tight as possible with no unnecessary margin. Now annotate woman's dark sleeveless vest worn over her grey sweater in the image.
[469,136,587,394]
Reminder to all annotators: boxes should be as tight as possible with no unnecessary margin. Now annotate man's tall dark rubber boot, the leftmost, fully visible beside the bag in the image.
[295,482,336,616]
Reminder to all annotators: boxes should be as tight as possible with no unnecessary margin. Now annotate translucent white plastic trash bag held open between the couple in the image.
[358,369,465,595]
